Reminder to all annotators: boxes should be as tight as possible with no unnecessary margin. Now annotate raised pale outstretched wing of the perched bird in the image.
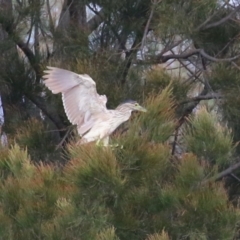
[43,67,107,135]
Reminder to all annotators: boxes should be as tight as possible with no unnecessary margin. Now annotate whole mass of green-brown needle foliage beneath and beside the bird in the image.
[0,85,239,240]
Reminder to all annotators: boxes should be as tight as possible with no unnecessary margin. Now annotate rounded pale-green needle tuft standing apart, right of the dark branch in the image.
[184,108,234,165]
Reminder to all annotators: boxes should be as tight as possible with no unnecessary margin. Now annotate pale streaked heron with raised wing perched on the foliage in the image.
[43,66,147,146]
